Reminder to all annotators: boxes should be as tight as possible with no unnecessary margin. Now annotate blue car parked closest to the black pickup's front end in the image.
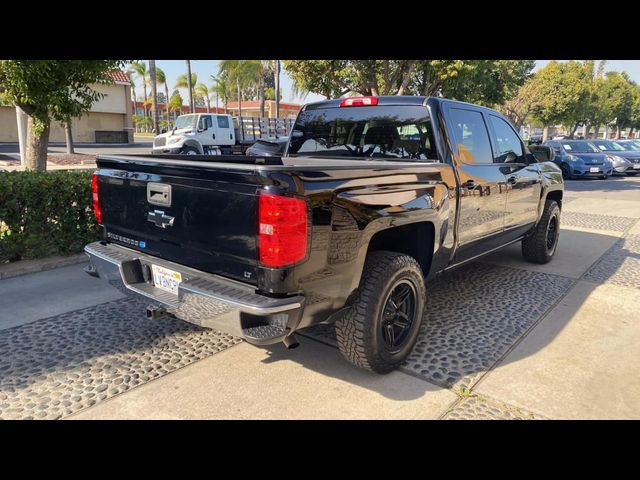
[544,140,613,179]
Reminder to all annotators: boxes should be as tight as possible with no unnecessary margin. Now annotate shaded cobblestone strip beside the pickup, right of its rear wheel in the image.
[304,263,573,388]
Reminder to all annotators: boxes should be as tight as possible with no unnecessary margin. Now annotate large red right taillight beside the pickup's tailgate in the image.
[258,195,307,267]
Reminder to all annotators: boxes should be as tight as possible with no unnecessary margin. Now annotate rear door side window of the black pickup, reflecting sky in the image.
[450,108,493,163]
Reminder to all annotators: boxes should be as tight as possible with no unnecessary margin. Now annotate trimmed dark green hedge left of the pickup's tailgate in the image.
[0,170,99,263]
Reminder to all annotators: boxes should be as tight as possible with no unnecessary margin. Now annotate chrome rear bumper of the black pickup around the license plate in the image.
[84,242,304,345]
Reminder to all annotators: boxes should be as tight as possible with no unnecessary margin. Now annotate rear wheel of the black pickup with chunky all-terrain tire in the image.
[336,251,426,373]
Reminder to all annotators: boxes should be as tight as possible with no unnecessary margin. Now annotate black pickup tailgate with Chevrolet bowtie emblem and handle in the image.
[98,157,264,284]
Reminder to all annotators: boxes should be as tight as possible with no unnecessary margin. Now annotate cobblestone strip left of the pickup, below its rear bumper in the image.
[0,298,240,419]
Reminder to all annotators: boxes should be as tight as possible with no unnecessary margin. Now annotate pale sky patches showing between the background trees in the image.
[136,60,640,108]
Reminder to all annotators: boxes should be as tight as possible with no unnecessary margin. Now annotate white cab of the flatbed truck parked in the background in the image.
[152,113,236,155]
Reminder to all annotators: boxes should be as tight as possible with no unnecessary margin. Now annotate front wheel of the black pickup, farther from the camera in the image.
[522,200,560,263]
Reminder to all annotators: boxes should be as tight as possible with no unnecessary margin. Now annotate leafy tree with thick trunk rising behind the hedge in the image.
[0,60,125,170]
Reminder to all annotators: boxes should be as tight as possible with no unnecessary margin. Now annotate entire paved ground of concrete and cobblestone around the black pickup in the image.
[0,177,640,419]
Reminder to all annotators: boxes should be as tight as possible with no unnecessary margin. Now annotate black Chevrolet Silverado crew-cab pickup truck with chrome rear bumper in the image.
[85,96,563,373]
